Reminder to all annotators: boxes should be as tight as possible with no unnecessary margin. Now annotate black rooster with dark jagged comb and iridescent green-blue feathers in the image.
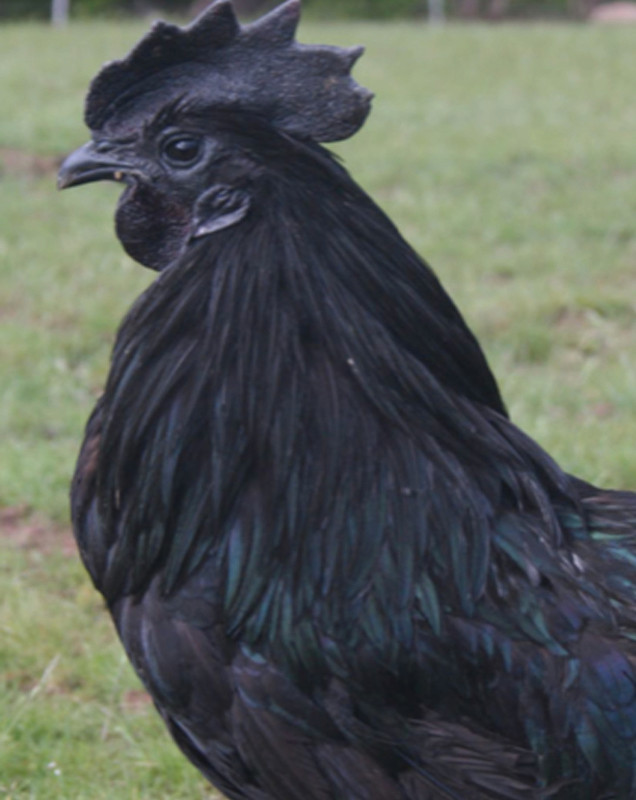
[60,0,636,800]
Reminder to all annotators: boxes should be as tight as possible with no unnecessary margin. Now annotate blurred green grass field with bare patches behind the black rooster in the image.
[0,17,636,800]
